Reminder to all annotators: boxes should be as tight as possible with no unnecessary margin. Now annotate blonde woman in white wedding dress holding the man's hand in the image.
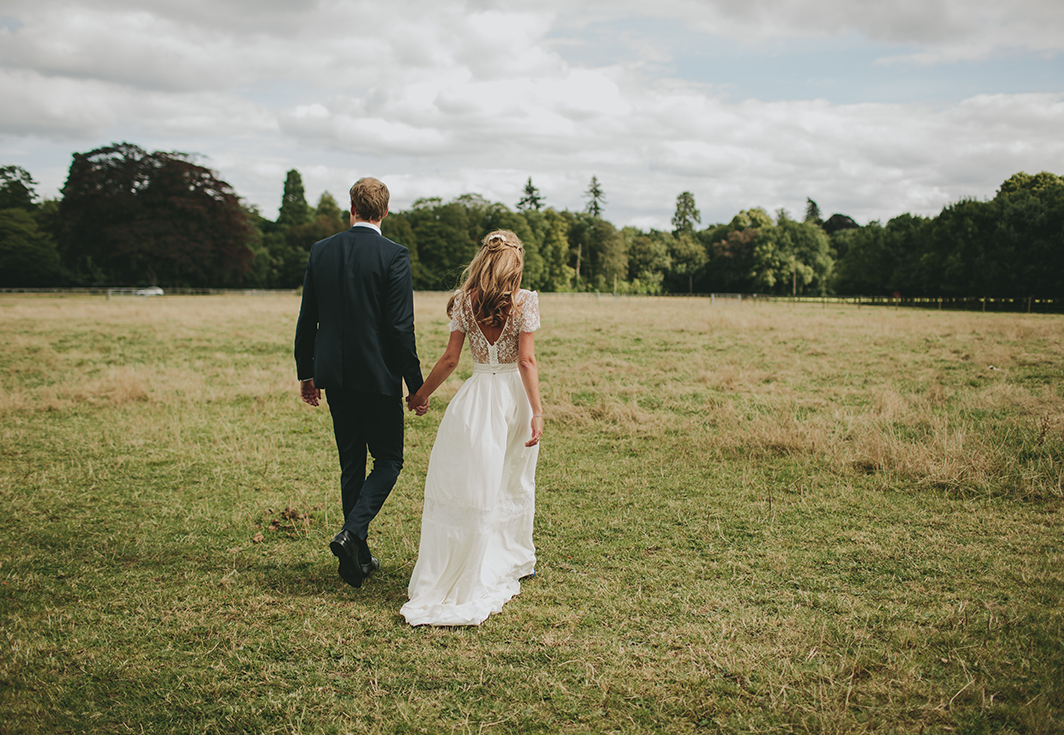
[400,230,543,625]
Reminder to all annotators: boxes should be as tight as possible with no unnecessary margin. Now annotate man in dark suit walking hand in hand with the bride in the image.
[296,178,423,587]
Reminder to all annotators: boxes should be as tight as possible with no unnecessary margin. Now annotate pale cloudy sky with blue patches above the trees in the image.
[0,0,1064,229]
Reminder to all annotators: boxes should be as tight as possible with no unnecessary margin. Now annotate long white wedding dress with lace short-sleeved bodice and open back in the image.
[400,289,539,625]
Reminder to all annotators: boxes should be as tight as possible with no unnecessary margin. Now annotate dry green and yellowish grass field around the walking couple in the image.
[0,294,1064,734]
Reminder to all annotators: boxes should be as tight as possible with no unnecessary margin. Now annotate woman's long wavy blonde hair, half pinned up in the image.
[447,230,525,327]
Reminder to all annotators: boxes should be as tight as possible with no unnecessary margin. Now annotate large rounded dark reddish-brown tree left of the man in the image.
[60,143,252,286]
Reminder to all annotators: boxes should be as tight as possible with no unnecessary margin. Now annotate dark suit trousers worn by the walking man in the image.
[326,388,403,564]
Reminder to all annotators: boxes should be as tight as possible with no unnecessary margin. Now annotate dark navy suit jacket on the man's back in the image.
[296,227,423,397]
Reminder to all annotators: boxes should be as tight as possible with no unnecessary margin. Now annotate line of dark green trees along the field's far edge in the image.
[0,143,1064,298]
